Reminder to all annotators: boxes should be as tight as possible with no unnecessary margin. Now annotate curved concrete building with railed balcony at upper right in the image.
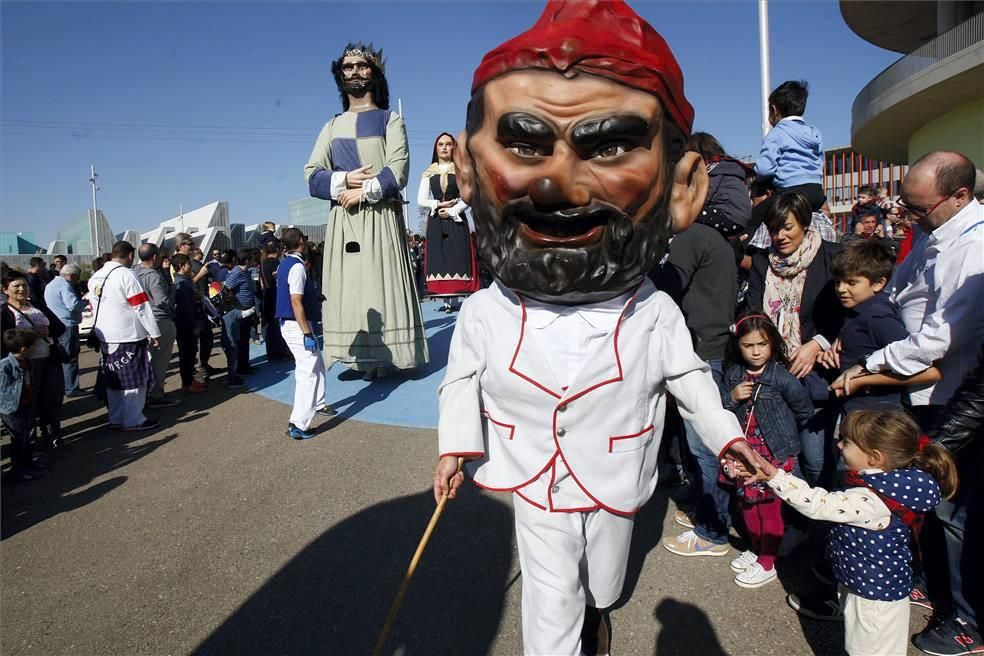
[840,0,984,168]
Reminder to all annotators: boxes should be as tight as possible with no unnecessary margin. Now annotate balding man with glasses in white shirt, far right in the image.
[834,151,984,656]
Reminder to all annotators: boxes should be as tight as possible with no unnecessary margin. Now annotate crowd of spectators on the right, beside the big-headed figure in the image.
[652,82,984,654]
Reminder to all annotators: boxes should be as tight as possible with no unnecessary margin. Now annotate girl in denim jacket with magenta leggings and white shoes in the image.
[721,313,813,588]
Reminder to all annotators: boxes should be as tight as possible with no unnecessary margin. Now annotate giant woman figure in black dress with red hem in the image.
[417,132,479,313]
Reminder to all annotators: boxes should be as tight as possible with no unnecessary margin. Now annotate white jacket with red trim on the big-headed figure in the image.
[438,279,742,515]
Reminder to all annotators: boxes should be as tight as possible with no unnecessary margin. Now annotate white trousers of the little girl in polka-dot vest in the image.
[838,586,909,656]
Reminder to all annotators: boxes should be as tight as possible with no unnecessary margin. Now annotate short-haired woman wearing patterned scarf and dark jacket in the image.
[747,192,844,485]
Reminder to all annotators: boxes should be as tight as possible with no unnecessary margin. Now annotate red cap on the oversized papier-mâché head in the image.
[472,0,694,136]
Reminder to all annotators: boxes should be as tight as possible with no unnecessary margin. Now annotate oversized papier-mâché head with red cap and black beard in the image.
[455,0,707,305]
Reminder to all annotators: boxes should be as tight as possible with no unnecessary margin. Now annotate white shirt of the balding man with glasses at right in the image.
[867,199,984,406]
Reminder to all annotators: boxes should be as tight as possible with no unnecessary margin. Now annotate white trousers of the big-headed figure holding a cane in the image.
[513,494,633,656]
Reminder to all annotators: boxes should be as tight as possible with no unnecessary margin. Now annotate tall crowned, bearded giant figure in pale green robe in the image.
[304,43,429,379]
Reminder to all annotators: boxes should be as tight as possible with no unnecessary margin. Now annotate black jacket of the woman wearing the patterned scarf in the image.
[745,241,844,343]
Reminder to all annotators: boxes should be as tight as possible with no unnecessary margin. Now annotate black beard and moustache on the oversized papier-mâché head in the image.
[471,185,672,305]
